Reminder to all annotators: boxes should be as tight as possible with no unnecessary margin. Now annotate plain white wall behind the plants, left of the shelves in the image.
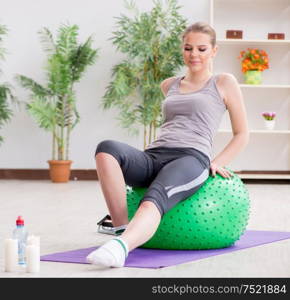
[0,0,209,169]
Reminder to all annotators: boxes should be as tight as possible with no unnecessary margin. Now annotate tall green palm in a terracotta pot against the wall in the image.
[16,25,98,182]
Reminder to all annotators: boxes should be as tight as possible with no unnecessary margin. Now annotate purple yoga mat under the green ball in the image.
[40,230,290,269]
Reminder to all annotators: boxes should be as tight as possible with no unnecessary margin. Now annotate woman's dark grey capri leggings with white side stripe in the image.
[96,140,210,216]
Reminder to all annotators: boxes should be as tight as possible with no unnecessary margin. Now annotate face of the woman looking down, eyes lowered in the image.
[182,32,217,72]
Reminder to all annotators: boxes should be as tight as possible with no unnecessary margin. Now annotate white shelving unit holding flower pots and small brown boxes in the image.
[210,0,290,179]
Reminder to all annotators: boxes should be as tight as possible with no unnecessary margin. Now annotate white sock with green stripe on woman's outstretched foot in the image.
[87,237,128,268]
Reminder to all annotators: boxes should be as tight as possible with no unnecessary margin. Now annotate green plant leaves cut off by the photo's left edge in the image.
[0,25,16,143]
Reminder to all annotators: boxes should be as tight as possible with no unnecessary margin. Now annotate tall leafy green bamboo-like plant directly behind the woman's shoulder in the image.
[102,0,186,148]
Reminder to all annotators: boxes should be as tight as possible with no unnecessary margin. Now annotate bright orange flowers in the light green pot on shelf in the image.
[238,48,269,73]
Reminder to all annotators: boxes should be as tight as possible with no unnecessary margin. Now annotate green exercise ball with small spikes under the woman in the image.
[127,174,250,250]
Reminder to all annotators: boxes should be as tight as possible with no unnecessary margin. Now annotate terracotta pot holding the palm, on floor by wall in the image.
[47,160,72,182]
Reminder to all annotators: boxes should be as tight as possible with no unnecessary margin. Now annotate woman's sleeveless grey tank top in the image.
[146,75,226,159]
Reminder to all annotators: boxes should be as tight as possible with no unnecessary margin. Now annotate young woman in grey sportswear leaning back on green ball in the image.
[87,22,249,267]
